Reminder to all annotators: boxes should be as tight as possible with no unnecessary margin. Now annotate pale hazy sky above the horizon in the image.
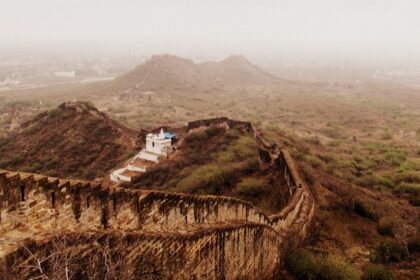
[0,0,420,61]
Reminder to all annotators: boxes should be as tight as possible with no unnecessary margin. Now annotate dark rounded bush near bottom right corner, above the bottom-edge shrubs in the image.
[370,241,408,263]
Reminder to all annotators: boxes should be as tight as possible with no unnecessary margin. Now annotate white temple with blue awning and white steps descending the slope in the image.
[110,129,176,182]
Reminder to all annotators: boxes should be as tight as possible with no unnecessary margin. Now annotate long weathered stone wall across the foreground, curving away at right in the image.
[0,148,315,279]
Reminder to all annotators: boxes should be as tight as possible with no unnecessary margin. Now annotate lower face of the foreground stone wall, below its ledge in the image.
[4,224,280,279]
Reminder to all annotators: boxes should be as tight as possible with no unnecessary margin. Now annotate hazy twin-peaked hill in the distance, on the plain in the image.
[116,55,280,91]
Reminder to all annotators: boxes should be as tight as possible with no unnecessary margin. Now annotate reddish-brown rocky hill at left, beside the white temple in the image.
[0,102,138,179]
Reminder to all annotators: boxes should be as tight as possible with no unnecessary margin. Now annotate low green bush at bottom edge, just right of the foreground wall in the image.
[286,250,360,280]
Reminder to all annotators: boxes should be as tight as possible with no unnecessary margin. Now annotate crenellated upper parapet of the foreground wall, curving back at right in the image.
[0,145,315,279]
